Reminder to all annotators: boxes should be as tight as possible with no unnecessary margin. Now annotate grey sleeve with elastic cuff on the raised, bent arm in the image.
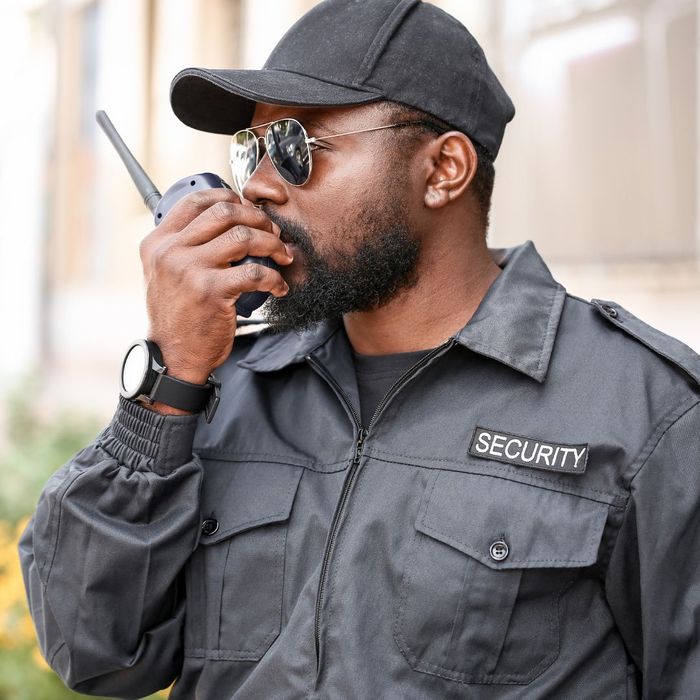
[19,399,202,697]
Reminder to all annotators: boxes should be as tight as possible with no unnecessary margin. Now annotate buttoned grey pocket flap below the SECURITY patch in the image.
[416,472,608,569]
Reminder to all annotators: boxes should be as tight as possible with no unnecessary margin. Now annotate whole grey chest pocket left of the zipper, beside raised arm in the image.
[185,460,303,661]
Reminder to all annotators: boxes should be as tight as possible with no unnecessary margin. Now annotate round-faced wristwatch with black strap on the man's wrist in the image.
[120,340,221,423]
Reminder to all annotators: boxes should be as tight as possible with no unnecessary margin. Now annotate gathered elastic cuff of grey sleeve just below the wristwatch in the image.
[100,396,198,474]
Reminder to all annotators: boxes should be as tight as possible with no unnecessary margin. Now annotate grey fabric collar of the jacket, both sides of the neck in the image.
[238,241,566,382]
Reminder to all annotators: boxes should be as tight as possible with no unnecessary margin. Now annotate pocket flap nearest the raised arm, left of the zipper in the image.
[200,460,304,545]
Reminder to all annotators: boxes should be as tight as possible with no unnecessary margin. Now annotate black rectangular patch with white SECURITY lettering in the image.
[469,427,588,474]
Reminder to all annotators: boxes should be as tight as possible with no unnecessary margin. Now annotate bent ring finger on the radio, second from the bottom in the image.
[197,224,294,267]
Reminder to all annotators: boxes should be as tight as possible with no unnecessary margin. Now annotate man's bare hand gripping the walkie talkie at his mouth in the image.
[140,188,292,396]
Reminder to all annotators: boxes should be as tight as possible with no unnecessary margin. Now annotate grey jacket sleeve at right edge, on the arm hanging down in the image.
[606,399,700,700]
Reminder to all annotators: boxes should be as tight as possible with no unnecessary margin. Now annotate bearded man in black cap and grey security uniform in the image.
[21,0,700,700]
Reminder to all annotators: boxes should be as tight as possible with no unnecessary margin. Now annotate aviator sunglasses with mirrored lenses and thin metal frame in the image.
[230,119,445,196]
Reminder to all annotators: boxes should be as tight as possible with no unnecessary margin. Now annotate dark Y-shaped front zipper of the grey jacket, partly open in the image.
[306,338,455,670]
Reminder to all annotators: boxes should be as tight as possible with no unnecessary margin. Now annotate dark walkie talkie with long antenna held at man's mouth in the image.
[95,110,279,318]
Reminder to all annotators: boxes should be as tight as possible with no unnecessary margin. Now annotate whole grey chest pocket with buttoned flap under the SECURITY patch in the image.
[394,472,608,684]
